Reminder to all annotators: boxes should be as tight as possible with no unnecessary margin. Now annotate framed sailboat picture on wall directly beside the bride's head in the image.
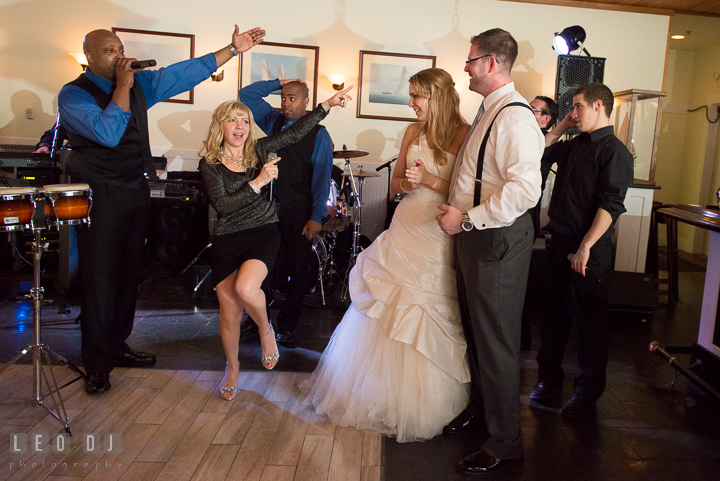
[356,50,436,122]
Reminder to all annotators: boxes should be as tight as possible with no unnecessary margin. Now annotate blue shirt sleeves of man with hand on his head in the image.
[239,79,333,223]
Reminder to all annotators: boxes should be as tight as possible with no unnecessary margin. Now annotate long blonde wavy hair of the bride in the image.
[409,68,467,165]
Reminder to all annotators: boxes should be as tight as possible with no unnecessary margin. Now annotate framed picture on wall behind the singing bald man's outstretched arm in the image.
[112,27,195,104]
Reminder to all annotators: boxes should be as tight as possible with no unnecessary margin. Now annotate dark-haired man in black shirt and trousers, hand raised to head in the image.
[530,83,634,418]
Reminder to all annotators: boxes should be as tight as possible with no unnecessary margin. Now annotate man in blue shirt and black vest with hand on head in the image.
[240,79,333,347]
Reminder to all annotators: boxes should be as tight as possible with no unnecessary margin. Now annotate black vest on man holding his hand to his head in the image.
[270,115,322,209]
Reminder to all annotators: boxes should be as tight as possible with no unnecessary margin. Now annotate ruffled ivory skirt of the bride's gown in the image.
[303,191,470,442]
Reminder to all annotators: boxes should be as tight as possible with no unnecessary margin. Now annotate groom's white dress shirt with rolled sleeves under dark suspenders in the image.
[449,82,545,229]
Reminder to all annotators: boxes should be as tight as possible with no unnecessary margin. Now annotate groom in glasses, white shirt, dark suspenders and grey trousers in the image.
[437,28,545,475]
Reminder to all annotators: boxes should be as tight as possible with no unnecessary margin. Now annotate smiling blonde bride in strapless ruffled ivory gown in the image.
[304,68,470,442]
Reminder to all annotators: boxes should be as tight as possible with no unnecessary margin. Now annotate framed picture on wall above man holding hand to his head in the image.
[238,42,320,109]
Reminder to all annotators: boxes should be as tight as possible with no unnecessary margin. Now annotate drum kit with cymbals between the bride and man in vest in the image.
[313,145,380,305]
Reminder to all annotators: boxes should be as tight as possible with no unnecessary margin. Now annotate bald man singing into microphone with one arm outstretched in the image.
[58,25,265,394]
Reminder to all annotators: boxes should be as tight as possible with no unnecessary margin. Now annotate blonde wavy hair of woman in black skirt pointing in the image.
[198,100,265,169]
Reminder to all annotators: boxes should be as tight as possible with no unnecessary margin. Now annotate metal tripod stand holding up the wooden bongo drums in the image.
[0,195,87,436]
